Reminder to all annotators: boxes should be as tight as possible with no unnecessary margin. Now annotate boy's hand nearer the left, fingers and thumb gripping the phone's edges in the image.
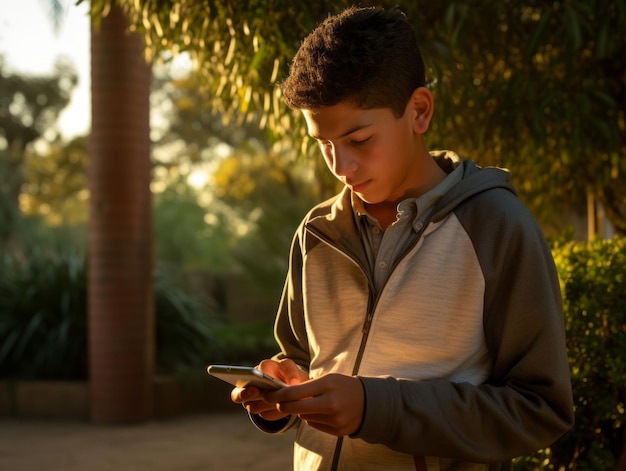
[230,359,309,421]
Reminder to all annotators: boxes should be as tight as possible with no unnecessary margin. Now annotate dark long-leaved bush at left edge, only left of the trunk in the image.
[0,253,87,379]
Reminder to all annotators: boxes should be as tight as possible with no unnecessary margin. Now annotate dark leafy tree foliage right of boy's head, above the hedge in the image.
[410,0,626,236]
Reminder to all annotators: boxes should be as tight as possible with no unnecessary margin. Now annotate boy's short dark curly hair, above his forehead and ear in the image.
[281,7,426,117]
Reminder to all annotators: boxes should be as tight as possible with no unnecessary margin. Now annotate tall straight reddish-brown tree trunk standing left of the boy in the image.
[88,3,154,423]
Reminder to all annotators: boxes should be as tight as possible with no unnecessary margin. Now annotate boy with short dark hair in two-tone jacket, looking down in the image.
[232,4,573,471]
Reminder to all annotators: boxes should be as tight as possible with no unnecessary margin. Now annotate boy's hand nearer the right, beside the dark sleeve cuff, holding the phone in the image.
[264,373,365,436]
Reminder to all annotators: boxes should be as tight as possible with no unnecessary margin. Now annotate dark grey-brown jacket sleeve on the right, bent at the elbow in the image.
[355,191,573,463]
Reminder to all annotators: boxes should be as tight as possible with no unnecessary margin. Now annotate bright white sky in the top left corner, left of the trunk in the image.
[0,0,91,137]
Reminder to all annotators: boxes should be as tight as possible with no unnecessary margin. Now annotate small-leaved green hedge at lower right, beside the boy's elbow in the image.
[516,238,626,471]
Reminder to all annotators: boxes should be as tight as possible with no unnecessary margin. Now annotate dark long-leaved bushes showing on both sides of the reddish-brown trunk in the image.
[0,252,229,380]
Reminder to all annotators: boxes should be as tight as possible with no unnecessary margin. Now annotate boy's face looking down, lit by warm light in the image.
[303,101,427,204]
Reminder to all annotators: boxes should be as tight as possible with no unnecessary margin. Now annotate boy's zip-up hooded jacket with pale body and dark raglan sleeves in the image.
[253,152,573,471]
